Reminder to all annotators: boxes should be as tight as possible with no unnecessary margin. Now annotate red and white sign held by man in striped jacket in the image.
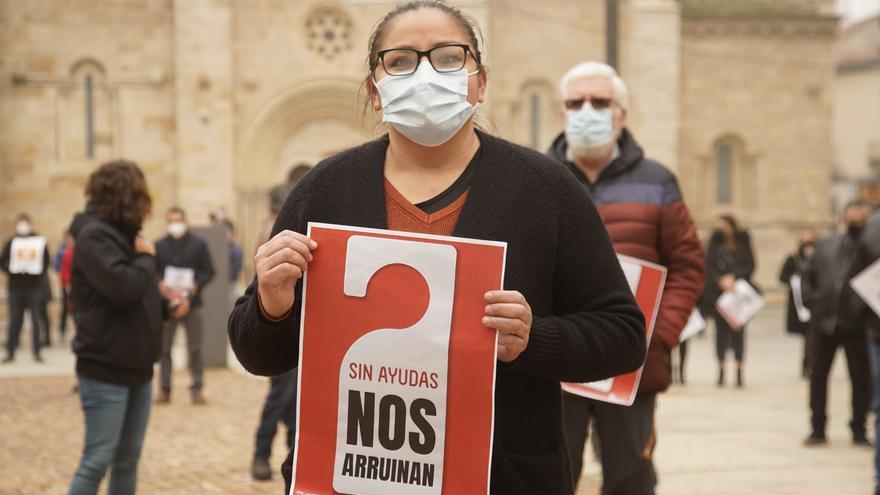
[562,255,666,406]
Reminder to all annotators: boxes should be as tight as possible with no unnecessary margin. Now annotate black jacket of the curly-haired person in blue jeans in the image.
[70,213,162,386]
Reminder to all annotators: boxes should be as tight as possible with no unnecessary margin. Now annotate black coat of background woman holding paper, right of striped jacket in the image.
[701,230,758,314]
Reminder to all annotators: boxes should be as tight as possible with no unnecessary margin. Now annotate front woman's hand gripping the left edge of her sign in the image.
[254,230,318,319]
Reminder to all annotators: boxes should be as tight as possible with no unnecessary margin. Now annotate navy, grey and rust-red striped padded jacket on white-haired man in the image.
[548,129,705,392]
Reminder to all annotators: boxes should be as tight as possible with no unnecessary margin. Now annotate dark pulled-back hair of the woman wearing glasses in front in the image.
[364,0,486,115]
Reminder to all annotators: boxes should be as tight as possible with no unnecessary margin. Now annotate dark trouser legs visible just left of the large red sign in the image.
[254,368,297,457]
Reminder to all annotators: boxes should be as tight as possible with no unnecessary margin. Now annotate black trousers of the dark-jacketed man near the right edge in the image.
[810,332,871,435]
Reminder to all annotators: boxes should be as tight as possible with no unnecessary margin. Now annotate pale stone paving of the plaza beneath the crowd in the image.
[0,310,872,495]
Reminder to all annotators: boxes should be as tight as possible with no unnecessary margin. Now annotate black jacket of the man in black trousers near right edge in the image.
[804,234,868,336]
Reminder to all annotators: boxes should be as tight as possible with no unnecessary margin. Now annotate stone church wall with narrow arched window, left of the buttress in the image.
[0,0,176,248]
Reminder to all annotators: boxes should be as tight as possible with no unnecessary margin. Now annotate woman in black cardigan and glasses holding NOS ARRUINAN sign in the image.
[229,1,646,495]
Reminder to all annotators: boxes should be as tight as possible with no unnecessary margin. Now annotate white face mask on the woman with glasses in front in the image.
[373,62,479,146]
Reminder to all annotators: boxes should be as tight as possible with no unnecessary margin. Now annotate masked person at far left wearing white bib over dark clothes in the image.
[0,213,49,363]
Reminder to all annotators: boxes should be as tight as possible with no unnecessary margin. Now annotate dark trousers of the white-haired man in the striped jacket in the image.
[562,392,657,495]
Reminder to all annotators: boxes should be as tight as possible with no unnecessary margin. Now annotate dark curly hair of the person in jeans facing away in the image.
[85,160,153,227]
